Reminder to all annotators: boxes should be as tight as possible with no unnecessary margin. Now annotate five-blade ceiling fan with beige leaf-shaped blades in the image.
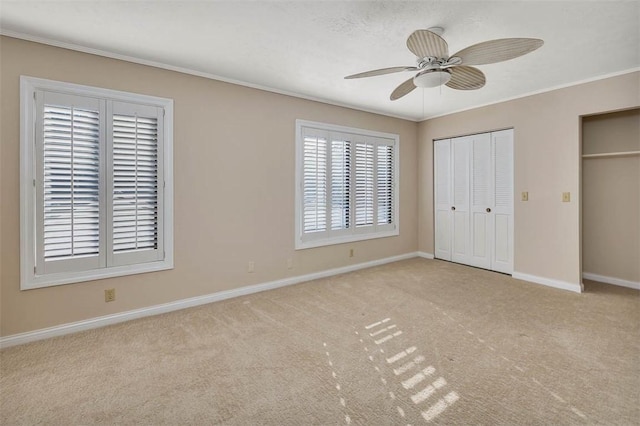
[345,27,544,101]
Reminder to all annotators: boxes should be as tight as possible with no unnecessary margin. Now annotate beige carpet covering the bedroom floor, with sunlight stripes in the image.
[0,259,640,426]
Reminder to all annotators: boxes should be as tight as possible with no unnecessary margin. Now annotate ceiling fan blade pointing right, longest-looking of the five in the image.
[451,38,544,65]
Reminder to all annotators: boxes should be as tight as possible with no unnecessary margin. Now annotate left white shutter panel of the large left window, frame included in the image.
[36,92,104,273]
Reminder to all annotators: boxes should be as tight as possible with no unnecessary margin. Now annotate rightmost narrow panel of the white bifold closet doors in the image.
[491,129,514,274]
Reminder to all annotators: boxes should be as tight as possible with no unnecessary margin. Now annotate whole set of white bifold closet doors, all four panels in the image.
[434,130,513,274]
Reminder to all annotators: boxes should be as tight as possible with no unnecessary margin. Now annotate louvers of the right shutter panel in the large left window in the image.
[113,114,158,253]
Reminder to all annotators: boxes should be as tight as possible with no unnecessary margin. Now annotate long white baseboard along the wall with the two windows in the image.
[0,252,420,349]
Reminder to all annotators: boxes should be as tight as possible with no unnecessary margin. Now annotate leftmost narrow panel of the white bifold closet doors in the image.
[433,139,453,260]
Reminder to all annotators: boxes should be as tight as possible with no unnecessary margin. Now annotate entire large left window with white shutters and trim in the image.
[20,77,173,290]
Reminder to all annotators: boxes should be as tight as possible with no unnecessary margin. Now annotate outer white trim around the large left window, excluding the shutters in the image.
[20,76,173,290]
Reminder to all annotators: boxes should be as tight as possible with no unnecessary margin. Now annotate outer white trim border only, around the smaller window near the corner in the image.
[294,119,400,250]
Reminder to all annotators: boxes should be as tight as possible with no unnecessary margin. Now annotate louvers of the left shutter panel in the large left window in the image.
[43,105,100,261]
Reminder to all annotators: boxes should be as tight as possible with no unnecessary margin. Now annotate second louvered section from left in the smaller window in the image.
[331,140,351,231]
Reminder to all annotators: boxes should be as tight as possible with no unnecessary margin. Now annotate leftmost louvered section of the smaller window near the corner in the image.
[302,136,327,233]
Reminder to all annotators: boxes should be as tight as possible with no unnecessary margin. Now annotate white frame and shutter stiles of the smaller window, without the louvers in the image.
[294,119,400,250]
